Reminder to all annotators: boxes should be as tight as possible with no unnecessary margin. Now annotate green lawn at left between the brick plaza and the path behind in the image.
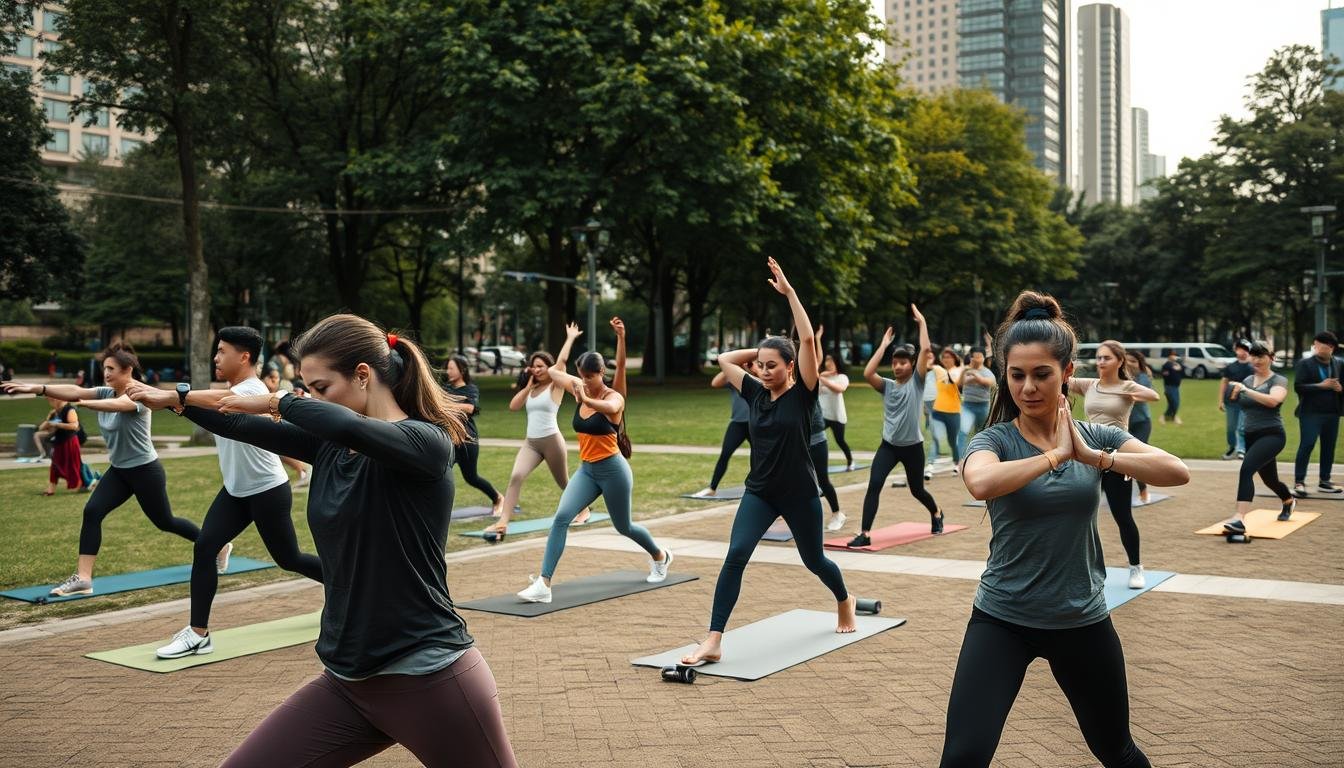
[0,448,747,629]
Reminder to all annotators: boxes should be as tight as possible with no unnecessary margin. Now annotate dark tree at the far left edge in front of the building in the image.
[0,3,85,301]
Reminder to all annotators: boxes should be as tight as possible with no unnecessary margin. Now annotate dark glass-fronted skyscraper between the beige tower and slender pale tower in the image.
[957,0,1073,184]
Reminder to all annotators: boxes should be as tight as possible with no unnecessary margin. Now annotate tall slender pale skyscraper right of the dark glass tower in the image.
[1078,3,1128,206]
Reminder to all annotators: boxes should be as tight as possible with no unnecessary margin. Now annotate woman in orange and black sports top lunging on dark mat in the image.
[517,323,672,603]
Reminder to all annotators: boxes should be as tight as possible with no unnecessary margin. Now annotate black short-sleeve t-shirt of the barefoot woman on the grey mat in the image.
[742,375,821,500]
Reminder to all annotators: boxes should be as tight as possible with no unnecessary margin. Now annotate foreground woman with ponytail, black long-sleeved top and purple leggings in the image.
[176,315,516,768]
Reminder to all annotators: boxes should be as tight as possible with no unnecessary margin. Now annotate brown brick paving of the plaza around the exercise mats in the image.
[0,472,1344,768]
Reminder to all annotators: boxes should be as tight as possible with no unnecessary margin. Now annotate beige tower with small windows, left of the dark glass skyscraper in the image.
[886,0,957,93]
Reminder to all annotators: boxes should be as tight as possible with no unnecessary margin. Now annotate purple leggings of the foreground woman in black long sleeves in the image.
[223,648,517,768]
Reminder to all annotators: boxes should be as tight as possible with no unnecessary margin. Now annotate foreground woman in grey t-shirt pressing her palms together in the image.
[941,291,1189,768]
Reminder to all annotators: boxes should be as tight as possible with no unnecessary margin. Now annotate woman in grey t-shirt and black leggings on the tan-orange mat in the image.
[1223,342,1297,534]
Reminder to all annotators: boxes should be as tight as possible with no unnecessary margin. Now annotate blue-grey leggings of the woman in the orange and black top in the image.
[542,453,663,580]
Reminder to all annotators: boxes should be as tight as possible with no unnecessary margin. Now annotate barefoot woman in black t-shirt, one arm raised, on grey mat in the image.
[681,258,856,666]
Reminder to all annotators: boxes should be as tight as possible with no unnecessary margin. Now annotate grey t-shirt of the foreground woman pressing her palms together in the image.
[966,421,1130,629]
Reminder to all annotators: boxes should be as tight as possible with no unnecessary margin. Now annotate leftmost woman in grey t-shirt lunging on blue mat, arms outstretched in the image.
[0,342,200,597]
